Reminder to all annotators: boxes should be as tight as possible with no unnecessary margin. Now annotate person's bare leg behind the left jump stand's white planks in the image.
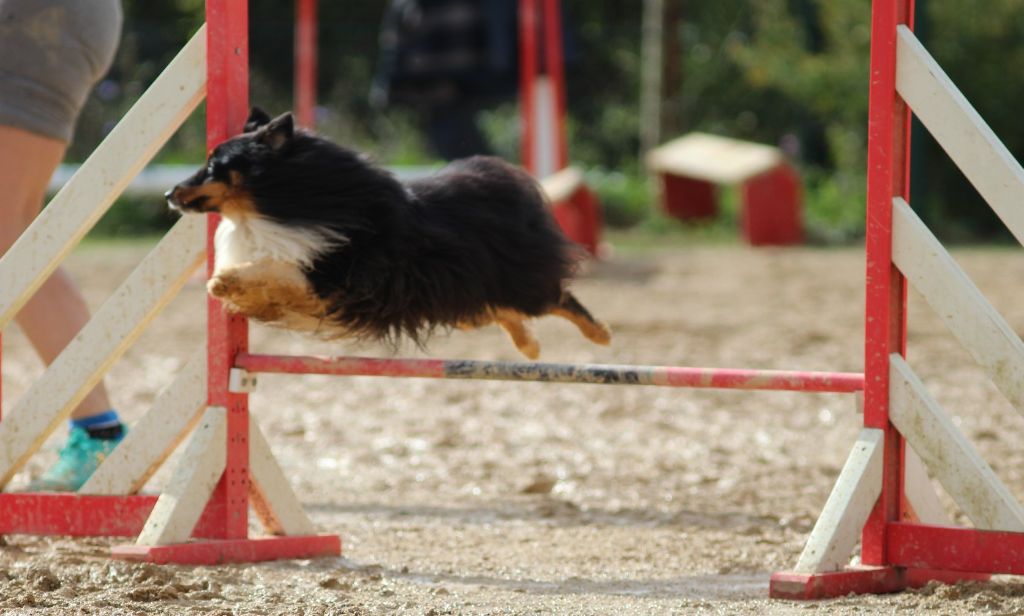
[0,126,111,419]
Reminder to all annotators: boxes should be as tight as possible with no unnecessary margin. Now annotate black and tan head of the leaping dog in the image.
[164,107,295,218]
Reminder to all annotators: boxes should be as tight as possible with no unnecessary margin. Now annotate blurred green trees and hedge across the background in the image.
[70,0,1024,241]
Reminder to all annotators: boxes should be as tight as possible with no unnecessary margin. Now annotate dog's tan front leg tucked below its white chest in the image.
[207,261,326,322]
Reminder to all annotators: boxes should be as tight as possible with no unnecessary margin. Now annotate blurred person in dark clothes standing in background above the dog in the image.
[370,0,518,161]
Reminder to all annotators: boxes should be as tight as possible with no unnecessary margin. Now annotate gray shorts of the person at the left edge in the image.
[0,0,122,141]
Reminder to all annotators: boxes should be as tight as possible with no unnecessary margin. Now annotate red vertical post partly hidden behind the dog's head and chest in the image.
[206,0,249,539]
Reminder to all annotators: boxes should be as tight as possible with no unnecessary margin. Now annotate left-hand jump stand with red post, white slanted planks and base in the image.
[0,0,341,564]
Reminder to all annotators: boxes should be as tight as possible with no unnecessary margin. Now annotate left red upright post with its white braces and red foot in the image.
[114,0,340,563]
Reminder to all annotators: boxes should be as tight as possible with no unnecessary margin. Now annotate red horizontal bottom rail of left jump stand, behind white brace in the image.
[0,492,224,537]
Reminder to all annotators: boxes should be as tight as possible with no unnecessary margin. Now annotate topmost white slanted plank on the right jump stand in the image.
[896,26,1024,244]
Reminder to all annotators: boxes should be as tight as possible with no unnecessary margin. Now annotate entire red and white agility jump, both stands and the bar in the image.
[0,0,1024,599]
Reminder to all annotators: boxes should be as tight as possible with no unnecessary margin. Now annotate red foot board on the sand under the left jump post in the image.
[111,535,341,565]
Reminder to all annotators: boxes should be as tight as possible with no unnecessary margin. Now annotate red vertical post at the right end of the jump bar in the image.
[861,0,913,565]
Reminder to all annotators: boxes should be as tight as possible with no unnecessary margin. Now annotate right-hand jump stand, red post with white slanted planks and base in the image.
[771,0,1024,599]
